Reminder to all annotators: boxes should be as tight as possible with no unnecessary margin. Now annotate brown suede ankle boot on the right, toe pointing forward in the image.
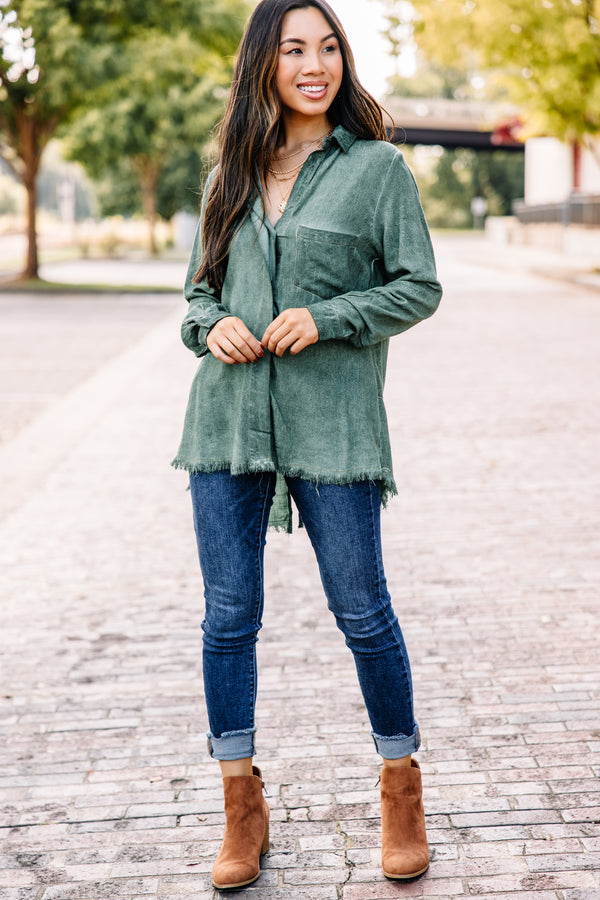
[381,759,429,879]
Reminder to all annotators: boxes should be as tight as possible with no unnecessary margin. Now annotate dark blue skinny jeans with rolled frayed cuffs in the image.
[190,471,420,760]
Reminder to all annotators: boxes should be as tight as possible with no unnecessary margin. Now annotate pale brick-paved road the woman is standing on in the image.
[0,243,600,900]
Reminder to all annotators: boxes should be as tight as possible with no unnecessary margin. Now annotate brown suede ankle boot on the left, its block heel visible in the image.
[212,766,269,890]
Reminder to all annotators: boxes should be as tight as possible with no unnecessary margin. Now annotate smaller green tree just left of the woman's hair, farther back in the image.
[67,28,240,253]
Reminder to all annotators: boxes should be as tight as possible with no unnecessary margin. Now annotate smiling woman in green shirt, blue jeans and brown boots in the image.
[174,0,441,889]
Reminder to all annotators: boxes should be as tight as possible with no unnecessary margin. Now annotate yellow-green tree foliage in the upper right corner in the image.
[388,0,600,154]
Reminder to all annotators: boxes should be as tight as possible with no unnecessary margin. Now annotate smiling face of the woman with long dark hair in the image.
[275,6,344,118]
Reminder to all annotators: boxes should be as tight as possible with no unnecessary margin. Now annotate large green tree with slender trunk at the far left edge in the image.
[0,0,244,277]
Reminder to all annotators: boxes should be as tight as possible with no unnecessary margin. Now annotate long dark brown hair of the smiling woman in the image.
[194,0,387,290]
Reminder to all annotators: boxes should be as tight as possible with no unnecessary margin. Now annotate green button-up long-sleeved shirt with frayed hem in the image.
[173,126,441,530]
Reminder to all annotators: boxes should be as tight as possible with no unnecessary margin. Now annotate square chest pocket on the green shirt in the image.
[294,225,373,300]
